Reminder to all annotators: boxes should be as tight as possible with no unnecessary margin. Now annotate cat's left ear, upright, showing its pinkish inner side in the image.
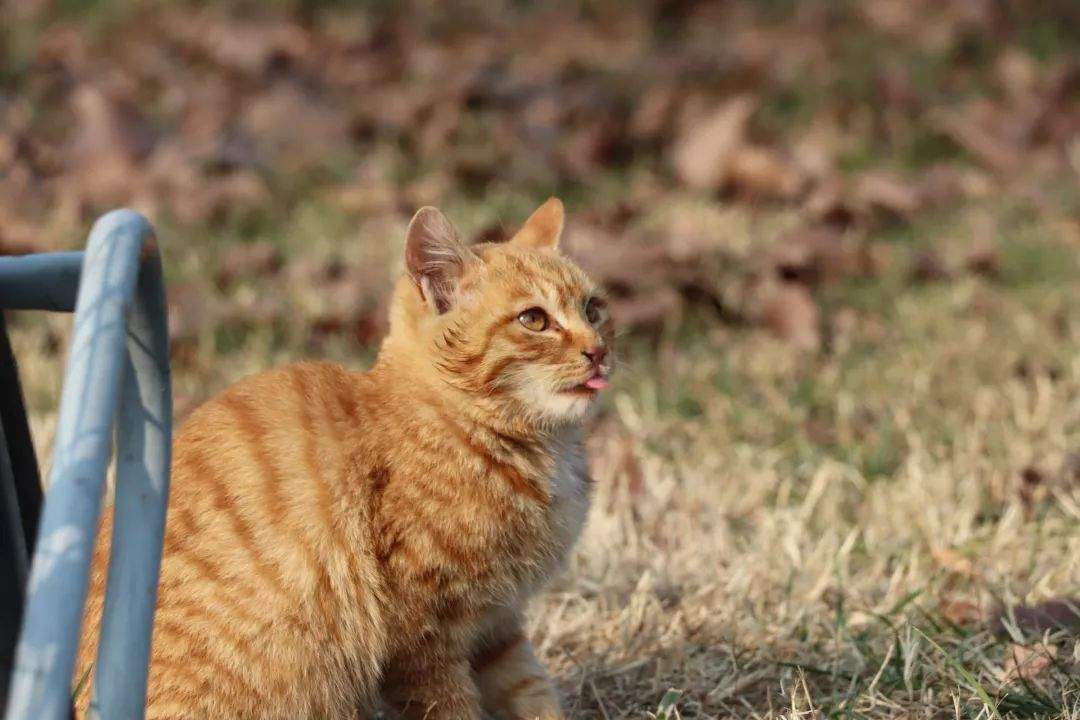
[405,207,476,314]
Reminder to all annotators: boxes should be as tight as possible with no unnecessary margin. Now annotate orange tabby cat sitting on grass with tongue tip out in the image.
[79,199,612,720]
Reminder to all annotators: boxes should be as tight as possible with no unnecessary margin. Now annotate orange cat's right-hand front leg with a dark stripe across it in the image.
[472,614,566,720]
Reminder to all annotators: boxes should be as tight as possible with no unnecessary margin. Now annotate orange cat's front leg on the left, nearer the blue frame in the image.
[382,638,483,720]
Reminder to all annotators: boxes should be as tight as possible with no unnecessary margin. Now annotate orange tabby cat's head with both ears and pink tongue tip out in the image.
[390,198,613,425]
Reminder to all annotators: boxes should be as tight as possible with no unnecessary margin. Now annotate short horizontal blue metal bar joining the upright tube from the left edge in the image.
[0,252,84,312]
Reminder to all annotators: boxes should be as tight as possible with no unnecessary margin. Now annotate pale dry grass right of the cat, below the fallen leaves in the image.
[535,221,1080,718]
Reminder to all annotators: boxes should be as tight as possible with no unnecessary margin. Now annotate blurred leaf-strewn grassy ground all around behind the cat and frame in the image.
[6,0,1080,719]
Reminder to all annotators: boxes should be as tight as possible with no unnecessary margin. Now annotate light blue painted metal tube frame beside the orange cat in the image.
[0,210,172,720]
